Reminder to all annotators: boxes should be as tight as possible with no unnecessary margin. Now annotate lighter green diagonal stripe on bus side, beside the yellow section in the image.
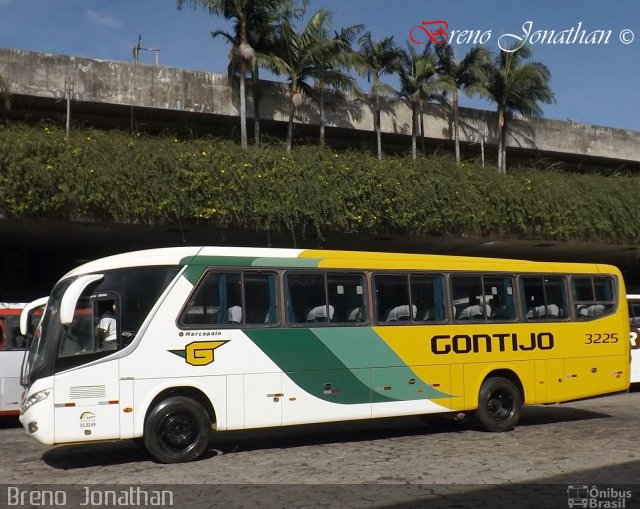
[313,327,450,401]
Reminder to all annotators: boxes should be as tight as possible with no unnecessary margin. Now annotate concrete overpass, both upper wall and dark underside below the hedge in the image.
[0,49,640,301]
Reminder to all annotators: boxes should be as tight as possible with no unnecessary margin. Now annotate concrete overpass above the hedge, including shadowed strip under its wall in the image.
[0,49,640,170]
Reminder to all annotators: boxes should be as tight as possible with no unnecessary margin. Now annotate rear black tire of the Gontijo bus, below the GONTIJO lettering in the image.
[473,377,522,432]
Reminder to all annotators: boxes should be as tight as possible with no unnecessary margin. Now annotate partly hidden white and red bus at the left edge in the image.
[0,302,27,416]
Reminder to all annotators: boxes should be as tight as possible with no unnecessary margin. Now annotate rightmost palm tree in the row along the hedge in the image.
[482,45,555,173]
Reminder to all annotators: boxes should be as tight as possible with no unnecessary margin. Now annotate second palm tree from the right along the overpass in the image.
[436,44,490,164]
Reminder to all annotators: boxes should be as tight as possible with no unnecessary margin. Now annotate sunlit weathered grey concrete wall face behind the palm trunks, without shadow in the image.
[0,49,640,166]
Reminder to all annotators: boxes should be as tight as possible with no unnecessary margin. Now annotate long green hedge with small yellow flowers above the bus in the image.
[0,125,640,243]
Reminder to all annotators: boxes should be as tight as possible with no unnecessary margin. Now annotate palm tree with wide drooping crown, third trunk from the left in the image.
[269,9,350,152]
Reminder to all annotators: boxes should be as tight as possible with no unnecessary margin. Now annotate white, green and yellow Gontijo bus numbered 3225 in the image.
[20,247,630,463]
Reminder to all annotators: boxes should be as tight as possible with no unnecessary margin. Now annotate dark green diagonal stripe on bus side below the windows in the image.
[244,328,395,404]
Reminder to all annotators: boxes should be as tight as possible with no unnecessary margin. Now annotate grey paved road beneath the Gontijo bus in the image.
[0,392,640,508]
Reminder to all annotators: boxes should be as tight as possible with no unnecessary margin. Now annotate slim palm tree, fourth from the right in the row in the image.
[356,32,399,159]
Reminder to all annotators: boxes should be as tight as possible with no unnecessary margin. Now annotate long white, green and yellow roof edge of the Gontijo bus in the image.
[62,246,619,279]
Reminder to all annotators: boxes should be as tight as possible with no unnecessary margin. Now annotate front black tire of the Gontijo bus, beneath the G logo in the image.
[144,396,211,463]
